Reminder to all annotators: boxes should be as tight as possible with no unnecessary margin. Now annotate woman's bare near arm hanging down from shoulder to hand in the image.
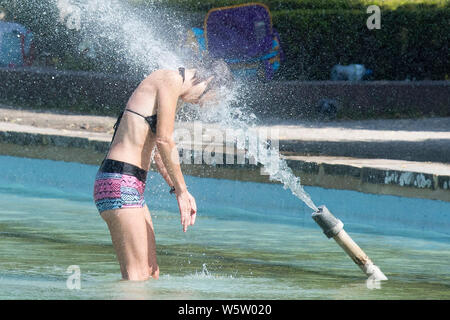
[156,75,197,232]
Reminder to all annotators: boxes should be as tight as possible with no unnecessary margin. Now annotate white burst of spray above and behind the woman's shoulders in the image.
[55,0,182,76]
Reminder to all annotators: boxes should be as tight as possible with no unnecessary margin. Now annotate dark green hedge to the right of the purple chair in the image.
[273,8,450,80]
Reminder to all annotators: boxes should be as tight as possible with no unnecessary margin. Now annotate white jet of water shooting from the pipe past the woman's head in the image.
[55,0,317,211]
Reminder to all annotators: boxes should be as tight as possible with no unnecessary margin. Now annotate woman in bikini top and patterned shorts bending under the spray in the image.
[94,62,231,281]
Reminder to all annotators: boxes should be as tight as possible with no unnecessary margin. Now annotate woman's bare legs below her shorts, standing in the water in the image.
[101,208,157,281]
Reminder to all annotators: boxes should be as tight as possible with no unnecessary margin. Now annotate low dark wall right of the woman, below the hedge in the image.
[239,81,450,119]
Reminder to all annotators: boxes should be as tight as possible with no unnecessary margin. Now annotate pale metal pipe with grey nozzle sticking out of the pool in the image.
[312,206,387,280]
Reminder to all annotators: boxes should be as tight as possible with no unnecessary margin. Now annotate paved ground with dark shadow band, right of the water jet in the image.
[262,118,450,163]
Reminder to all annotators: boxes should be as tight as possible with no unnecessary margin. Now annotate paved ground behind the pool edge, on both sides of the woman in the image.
[0,105,450,175]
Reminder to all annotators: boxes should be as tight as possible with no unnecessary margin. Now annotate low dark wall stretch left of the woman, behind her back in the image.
[0,68,139,115]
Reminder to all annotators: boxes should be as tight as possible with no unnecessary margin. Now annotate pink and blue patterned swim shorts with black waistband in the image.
[94,159,147,213]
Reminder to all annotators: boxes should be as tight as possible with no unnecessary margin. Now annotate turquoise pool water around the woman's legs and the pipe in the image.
[0,156,450,299]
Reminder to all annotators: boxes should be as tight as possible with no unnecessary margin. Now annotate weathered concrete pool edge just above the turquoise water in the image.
[0,128,450,202]
